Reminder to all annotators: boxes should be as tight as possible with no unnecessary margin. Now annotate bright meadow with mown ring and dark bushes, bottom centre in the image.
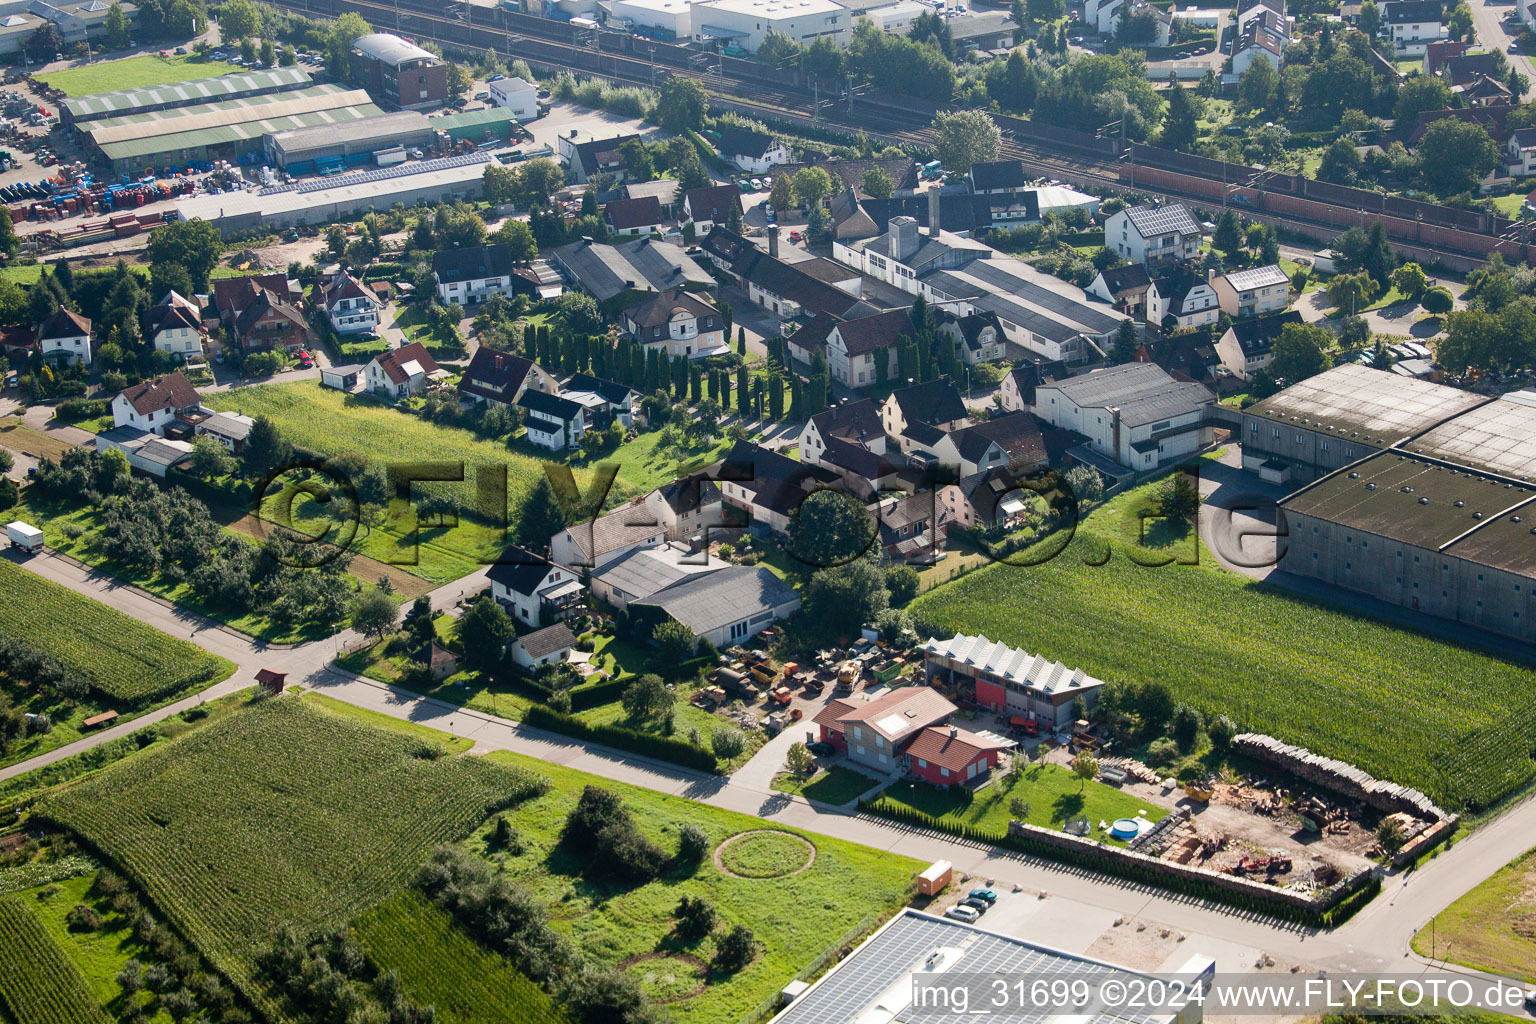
[468,751,923,1024]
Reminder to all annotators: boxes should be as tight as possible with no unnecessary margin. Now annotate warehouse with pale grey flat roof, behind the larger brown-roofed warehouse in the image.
[1241,362,1488,484]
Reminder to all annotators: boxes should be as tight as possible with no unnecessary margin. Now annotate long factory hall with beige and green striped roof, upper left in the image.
[78,84,382,173]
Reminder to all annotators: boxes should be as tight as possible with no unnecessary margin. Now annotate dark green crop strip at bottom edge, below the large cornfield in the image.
[353,890,564,1024]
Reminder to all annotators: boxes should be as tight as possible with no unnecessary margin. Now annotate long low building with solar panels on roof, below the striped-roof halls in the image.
[177,152,496,236]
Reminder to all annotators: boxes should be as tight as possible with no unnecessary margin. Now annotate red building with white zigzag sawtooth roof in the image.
[923,633,1104,731]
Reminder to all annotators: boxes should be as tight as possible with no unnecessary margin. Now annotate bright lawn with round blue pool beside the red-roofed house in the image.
[882,763,1167,846]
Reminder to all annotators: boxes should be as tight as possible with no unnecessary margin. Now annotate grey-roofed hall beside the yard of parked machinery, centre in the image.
[630,565,800,649]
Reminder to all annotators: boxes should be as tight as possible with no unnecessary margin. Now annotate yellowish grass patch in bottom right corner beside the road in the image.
[1413,849,1536,984]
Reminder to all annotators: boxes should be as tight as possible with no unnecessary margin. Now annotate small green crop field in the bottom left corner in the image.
[0,897,111,1024]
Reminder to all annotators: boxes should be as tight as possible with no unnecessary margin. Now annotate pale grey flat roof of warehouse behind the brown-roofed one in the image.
[1243,362,1488,448]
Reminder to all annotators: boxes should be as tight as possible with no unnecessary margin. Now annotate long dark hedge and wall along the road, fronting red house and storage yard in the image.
[859,797,1381,927]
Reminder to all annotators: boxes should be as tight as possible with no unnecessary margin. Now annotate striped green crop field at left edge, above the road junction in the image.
[0,559,235,706]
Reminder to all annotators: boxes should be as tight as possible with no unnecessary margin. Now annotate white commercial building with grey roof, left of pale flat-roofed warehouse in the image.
[1035,362,1215,473]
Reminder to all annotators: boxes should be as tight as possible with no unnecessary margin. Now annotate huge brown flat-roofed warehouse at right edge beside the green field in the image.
[1279,391,1536,642]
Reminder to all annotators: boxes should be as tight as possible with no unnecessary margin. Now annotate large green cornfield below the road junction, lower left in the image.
[38,697,536,1007]
